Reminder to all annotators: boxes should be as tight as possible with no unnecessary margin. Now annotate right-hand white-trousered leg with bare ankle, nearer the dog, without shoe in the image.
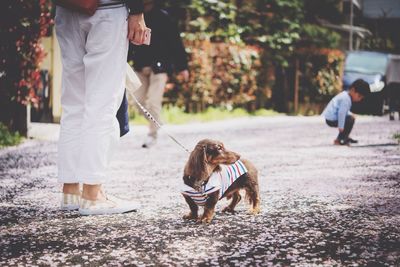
[77,8,128,200]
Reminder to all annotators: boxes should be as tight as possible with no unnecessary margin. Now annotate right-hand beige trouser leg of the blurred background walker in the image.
[146,72,168,138]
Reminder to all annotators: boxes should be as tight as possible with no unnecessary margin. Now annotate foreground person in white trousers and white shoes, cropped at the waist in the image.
[55,0,146,215]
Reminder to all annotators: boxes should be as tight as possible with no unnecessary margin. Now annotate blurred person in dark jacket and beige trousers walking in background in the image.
[128,0,189,148]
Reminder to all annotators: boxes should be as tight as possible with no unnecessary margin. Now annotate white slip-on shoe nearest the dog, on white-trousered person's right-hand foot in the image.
[79,196,139,215]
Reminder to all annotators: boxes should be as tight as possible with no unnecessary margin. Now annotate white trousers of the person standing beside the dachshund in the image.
[55,6,128,184]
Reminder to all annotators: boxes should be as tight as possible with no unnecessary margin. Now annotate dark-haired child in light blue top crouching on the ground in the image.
[322,79,370,145]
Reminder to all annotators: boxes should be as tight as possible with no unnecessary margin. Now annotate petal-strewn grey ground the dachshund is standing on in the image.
[0,116,400,266]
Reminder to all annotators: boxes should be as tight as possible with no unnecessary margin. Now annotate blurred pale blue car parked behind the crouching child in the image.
[343,51,389,115]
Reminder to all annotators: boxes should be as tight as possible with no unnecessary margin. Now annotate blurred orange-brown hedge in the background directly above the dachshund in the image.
[165,40,261,112]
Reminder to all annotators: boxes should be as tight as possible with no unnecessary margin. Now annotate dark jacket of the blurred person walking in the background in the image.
[128,8,188,74]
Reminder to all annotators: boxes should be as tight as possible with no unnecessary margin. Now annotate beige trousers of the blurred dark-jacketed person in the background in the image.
[135,67,168,137]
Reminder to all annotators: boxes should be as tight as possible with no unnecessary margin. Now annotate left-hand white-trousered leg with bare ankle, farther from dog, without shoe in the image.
[55,6,85,195]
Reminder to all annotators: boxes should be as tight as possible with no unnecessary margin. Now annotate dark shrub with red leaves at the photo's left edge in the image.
[0,0,52,131]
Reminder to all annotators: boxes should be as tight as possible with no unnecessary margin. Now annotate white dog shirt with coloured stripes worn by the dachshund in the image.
[181,160,247,206]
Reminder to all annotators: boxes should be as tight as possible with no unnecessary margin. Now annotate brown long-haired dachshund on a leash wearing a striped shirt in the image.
[182,139,260,223]
